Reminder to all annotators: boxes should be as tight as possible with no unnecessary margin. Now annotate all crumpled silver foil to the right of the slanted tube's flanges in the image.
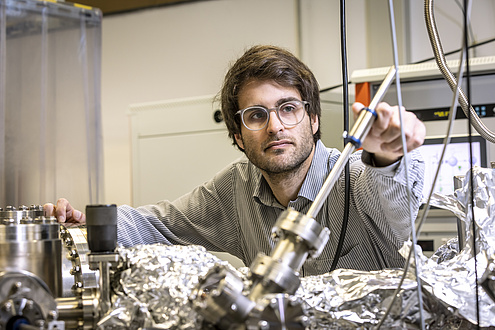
[286,168,495,329]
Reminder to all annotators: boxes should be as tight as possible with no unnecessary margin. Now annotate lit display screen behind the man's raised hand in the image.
[419,136,487,198]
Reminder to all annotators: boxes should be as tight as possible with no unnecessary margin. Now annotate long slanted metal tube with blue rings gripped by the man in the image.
[306,67,395,218]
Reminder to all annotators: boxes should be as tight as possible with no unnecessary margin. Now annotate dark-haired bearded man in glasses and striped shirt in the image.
[45,46,425,275]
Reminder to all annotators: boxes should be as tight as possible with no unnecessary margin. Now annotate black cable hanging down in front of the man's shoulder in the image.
[330,0,351,271]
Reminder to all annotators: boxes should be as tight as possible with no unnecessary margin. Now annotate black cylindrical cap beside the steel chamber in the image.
[86,204,117,252]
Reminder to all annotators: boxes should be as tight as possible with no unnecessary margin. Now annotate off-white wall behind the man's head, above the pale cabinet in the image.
[102,0,495,204]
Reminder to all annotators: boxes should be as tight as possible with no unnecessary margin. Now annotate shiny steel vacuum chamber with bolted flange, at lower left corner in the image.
[0,206,101,330]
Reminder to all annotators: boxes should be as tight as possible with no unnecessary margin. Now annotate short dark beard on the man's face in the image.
[241,122,315,176]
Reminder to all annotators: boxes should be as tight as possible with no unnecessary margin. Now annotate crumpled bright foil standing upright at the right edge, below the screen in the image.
[419,167,495,327]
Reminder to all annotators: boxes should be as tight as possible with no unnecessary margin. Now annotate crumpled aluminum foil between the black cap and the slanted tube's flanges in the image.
[98,244,239,329]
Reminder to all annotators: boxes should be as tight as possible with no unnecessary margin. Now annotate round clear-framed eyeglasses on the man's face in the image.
[236,100,309,131]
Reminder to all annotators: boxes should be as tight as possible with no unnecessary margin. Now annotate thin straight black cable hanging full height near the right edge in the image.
[463,0,480,329]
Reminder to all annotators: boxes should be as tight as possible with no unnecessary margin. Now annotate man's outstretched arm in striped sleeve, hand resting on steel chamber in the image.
[44,162,240,255]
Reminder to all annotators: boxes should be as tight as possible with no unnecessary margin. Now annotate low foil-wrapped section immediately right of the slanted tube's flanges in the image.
[296,269,419,329]
